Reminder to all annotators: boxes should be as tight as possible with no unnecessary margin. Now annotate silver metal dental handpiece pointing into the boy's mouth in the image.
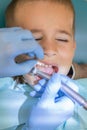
[32,68,87,110]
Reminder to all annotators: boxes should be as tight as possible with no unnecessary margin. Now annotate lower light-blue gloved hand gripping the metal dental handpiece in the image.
[23,74,78,130]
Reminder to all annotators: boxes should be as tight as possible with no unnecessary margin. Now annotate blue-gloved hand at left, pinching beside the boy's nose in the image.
[0,27,43,77]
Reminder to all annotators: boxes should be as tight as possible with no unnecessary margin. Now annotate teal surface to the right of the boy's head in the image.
[72,0,87,64]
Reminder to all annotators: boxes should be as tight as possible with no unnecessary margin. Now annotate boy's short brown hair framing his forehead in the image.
[6,0,75,83]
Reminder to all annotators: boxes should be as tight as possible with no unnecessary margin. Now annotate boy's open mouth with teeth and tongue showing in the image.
[23,61,58,86]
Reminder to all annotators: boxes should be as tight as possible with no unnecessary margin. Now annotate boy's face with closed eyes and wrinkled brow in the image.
[15,1,75,86]
